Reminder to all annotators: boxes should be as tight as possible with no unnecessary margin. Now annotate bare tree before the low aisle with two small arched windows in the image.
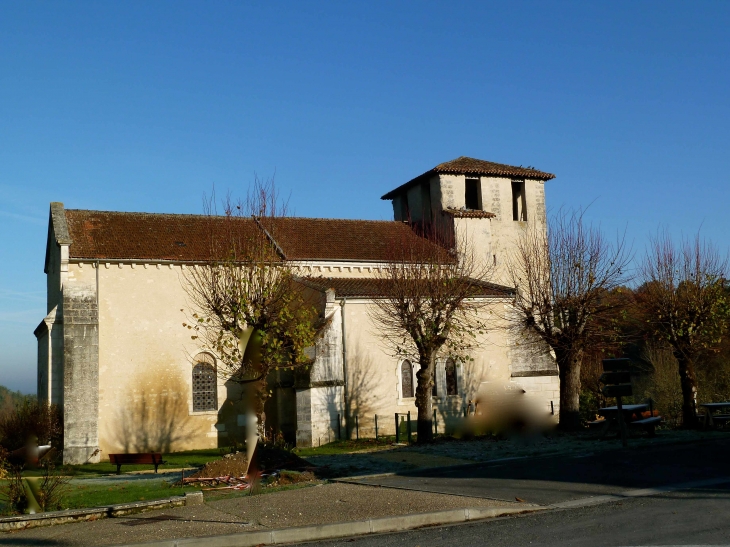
[372,226,498,443]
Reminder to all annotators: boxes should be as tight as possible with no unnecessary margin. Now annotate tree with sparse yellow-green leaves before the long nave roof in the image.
[183,178,317,428]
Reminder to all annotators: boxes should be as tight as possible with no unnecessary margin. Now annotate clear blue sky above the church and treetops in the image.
[0,0,730,392]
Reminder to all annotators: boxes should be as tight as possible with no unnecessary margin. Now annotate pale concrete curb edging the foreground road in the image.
[119,507,547,547]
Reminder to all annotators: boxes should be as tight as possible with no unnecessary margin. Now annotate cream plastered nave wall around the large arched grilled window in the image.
[67,262,243,458]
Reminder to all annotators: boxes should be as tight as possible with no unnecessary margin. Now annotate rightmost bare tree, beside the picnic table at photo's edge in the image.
[637,232,730,427]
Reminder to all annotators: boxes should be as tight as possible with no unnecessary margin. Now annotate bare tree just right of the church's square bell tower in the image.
[506,209,631,430]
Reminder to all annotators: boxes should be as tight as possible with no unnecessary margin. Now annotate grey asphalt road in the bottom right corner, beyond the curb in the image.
[298,484,730,547]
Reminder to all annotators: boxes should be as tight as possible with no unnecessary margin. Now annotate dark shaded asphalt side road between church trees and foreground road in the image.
[346,438,730,505]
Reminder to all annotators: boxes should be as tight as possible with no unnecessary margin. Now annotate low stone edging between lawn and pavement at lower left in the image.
[0,492,203,532]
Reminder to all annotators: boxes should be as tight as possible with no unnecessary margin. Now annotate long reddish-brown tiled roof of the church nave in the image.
[65,209,450,262]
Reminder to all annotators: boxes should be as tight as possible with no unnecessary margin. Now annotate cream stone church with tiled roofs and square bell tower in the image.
[35,157,559,463]
